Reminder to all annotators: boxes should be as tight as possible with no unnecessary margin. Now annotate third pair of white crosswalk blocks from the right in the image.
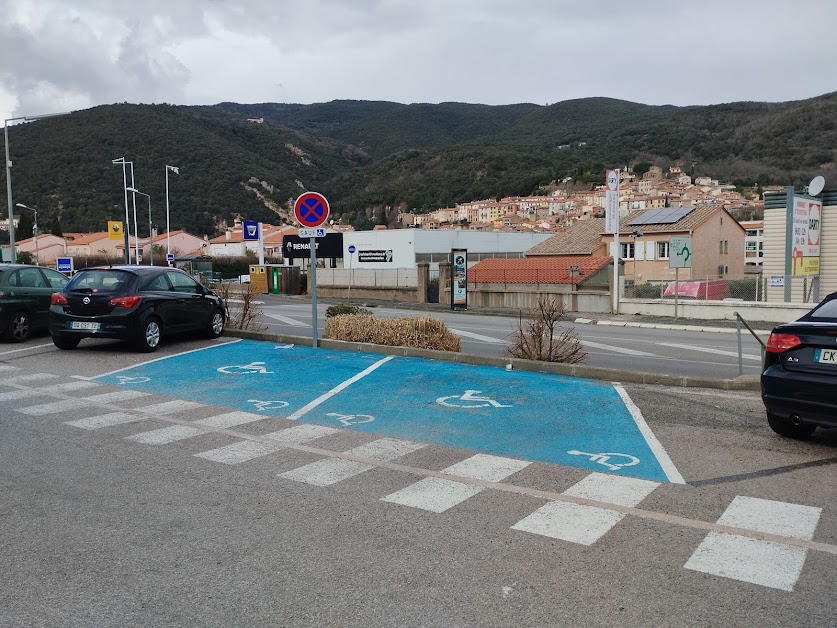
[381,454,531,513]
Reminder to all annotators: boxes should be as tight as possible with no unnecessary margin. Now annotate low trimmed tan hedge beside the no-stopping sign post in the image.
[324,314,462,352]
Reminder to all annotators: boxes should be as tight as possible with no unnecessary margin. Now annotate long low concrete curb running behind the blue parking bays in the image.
[224,329,761,390]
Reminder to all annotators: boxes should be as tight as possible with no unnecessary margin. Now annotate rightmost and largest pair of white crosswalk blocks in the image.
[685,495,822,591]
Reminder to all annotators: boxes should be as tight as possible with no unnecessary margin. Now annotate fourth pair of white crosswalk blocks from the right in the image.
[279,438,425,486]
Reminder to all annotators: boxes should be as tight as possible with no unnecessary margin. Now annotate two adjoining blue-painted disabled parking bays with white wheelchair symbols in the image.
[99,340,679,482]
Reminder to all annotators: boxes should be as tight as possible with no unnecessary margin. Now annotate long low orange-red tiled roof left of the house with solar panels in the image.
[468,255,611,284]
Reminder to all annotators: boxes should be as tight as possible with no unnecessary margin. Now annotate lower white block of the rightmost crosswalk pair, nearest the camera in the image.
[685,532,808,591]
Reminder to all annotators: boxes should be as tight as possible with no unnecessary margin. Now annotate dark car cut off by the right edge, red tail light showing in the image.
[761,292,837,438]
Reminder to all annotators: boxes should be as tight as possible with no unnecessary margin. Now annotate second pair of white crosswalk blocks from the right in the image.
[512,473,660,545]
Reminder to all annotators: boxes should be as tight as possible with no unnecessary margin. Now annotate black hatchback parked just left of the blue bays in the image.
[49,266,224,352]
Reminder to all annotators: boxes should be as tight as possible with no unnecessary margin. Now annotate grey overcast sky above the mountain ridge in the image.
[0,0,837,118]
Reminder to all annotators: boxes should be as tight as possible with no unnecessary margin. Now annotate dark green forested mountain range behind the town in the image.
[0,93,837,236]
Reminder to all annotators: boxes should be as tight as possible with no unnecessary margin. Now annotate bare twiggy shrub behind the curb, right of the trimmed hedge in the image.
[506,295,587,364]
